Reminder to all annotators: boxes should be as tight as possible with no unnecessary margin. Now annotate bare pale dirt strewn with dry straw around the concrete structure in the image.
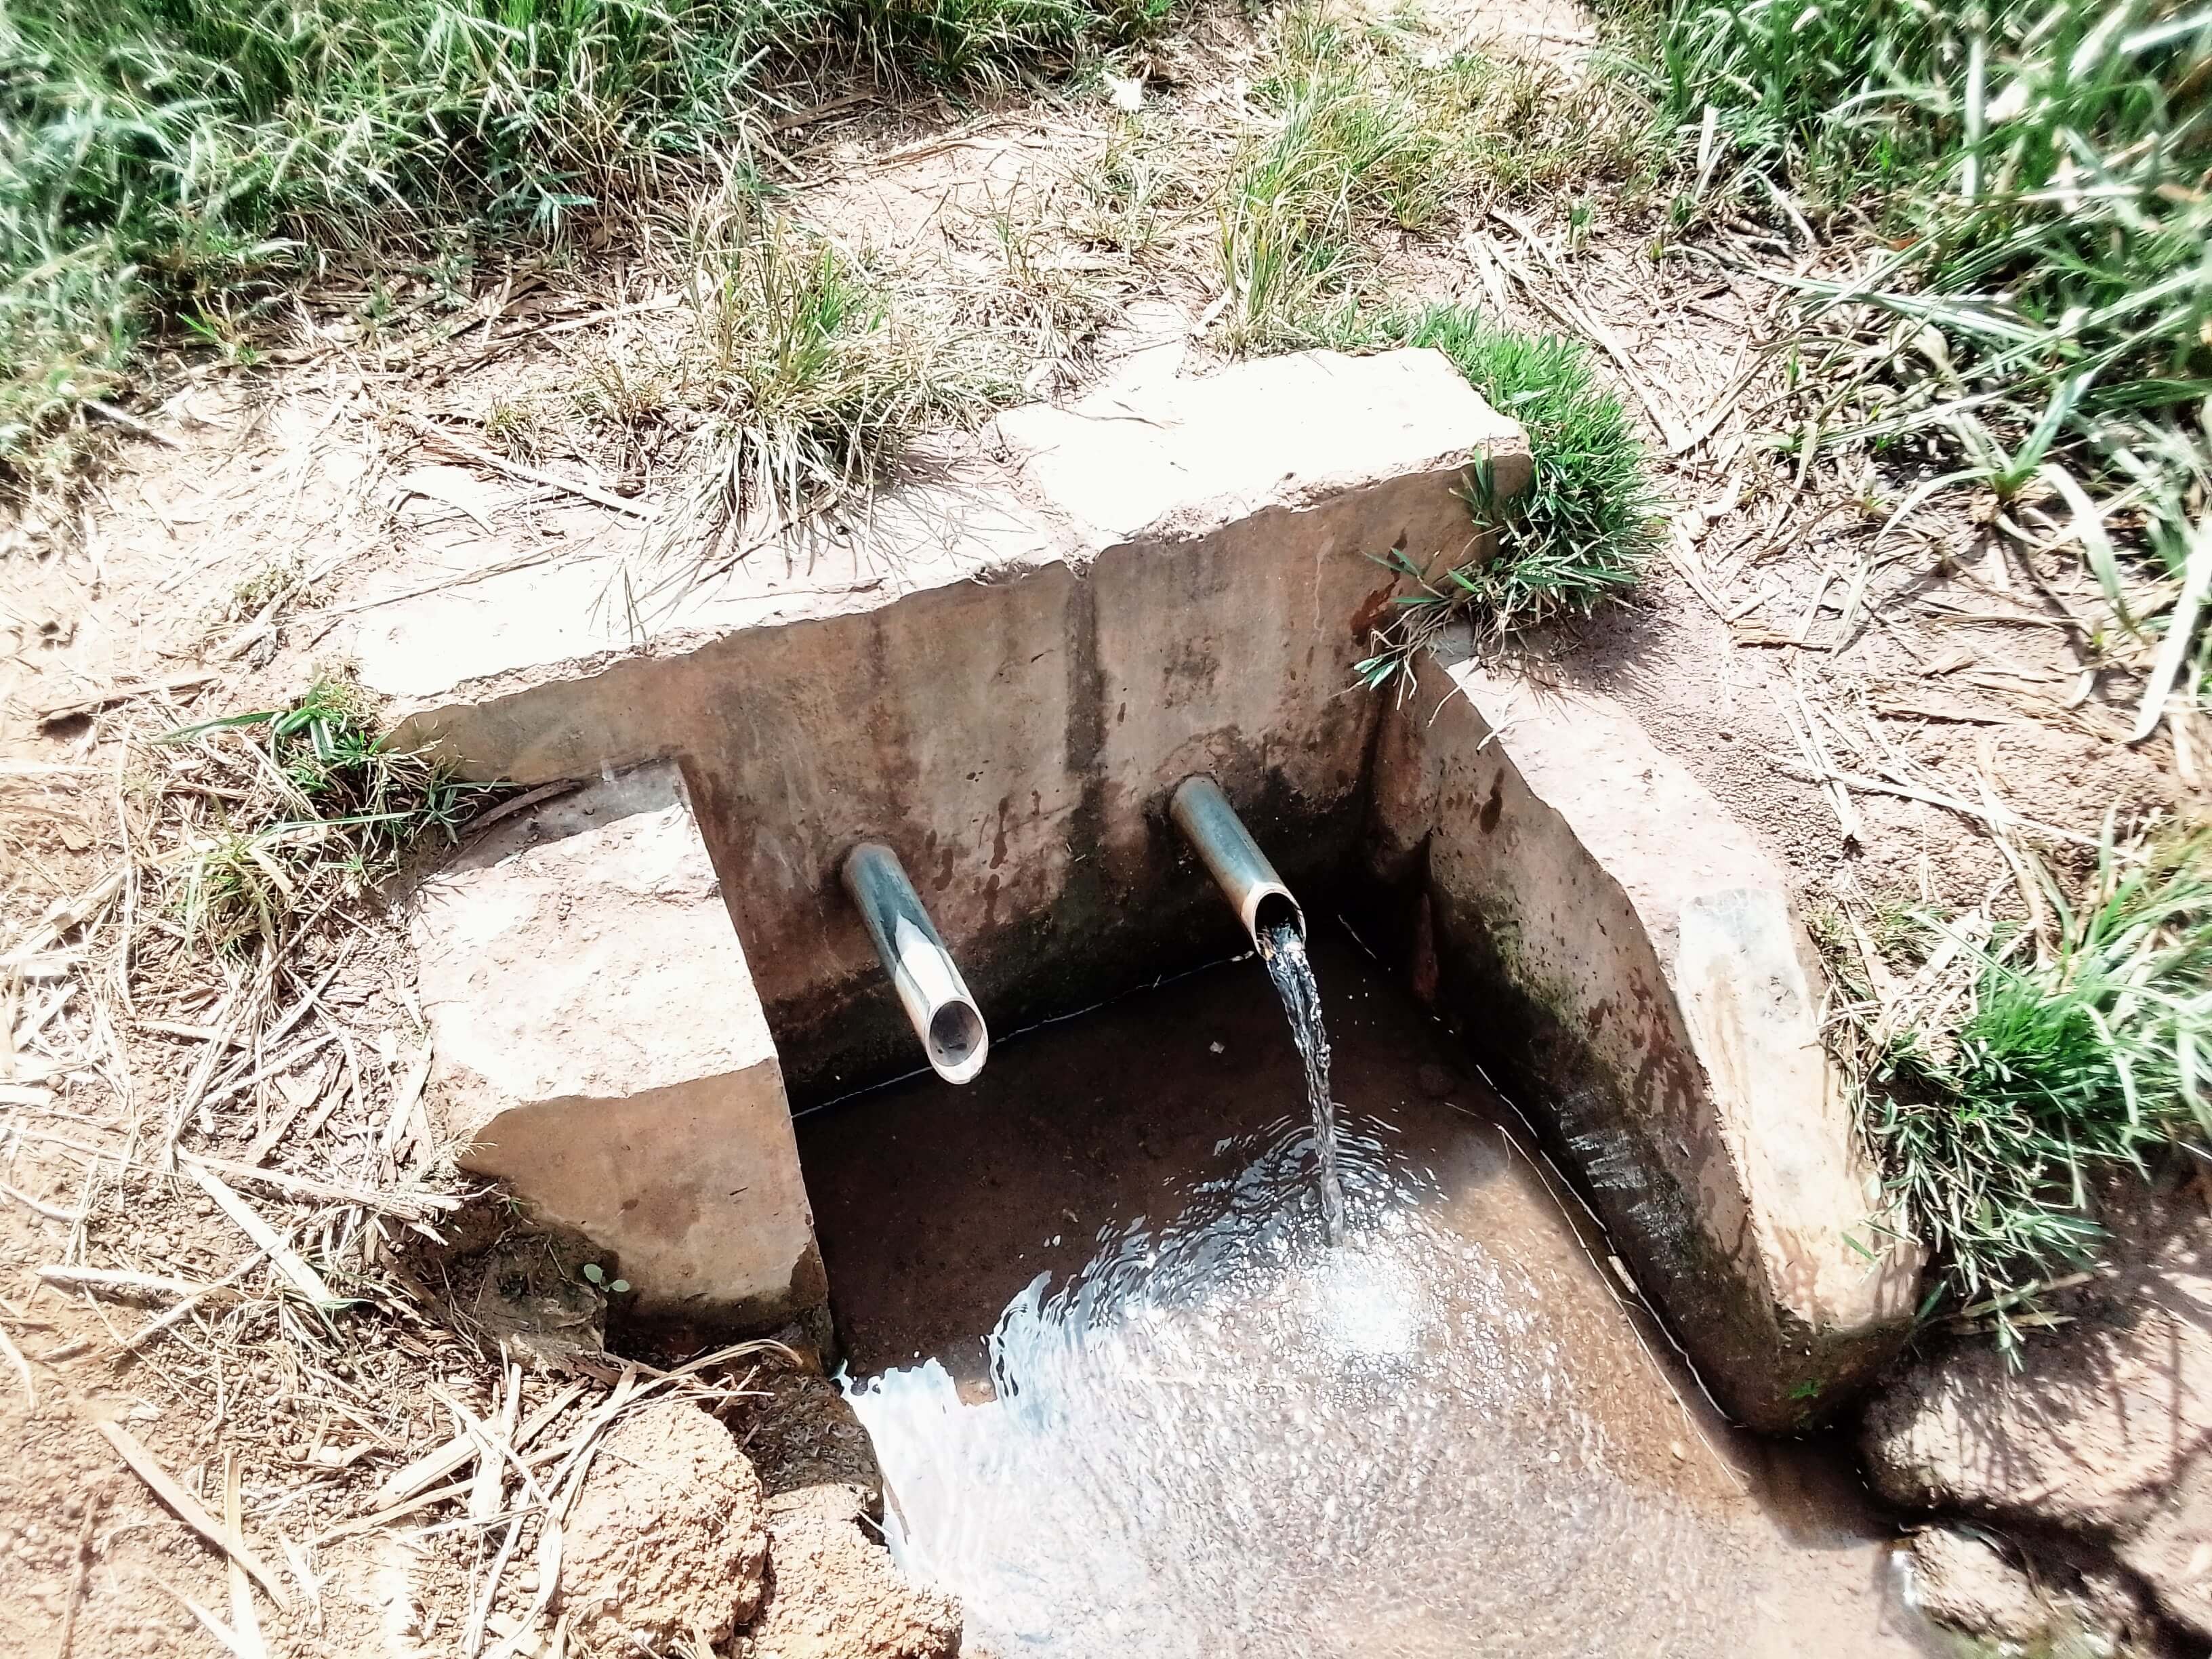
[0,7,2212,1659]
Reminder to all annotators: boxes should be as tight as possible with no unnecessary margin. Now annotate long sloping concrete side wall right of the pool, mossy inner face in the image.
[1374,659,1920,1429]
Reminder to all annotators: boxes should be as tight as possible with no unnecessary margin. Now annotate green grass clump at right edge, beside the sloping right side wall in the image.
[1847,832,2212,1345]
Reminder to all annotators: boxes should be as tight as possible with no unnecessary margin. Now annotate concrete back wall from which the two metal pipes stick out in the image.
[356,352,1528,1097]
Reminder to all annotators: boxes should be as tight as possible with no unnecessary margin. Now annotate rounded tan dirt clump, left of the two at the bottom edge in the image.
[562,1400,768,1654]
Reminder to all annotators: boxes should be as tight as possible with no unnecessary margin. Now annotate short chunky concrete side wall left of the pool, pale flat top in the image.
[409,765,825,1330]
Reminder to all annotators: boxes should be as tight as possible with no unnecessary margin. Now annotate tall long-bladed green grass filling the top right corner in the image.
[1615,0,2212,725]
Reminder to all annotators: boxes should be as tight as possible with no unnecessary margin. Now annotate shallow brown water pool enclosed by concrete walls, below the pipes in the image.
[798,942,1936,1659]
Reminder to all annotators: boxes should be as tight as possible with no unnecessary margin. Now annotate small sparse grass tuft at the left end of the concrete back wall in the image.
[159,679,495,951]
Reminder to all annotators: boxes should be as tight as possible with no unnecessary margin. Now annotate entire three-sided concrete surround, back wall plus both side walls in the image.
[384,352,1911,1427]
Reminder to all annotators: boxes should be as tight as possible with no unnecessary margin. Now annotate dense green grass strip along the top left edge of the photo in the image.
[0,0,1166,483]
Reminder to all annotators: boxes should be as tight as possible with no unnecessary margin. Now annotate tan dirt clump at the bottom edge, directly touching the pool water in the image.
[732,1515,960,1659]
